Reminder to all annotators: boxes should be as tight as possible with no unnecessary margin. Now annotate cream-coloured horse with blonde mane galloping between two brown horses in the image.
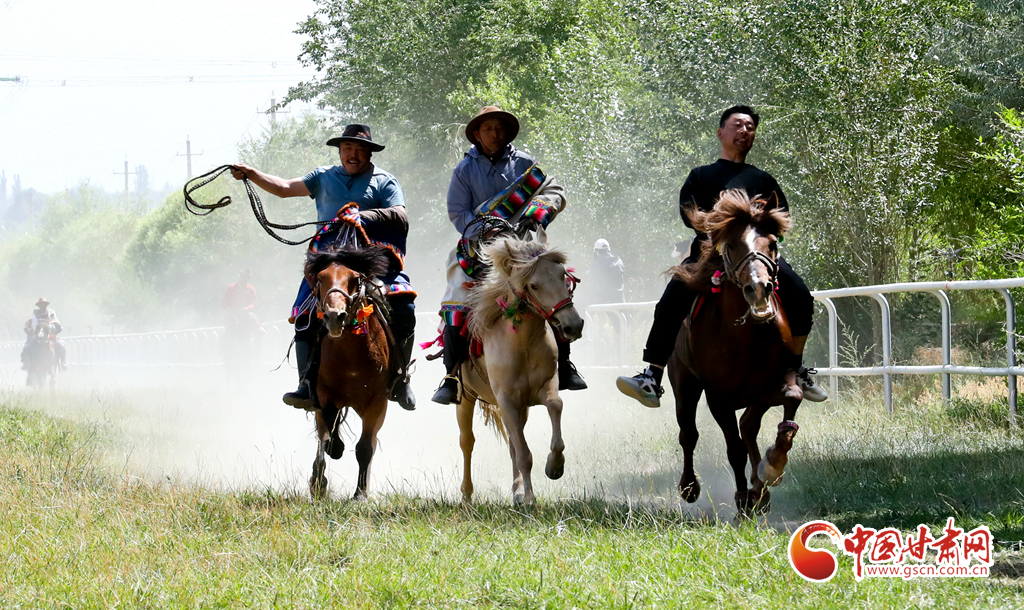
[457,229,584,505]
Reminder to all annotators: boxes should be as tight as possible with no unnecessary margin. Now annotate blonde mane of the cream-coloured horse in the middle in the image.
[469,236,567,337]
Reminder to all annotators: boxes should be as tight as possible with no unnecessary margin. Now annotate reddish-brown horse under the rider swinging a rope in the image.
[305,246,390,499]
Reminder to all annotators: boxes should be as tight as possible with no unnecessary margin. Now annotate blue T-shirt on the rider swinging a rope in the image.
[302,165,406,221]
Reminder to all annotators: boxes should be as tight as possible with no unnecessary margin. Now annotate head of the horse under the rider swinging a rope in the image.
[305,246,391,339]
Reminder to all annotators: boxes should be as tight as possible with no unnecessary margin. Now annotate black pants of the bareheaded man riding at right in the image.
[643,257,814,366]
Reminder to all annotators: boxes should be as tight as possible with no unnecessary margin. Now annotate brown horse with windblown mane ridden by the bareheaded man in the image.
[669,190,803,516]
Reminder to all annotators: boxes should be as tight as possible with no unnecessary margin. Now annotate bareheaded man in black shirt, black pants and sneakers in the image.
[615,105,828,407]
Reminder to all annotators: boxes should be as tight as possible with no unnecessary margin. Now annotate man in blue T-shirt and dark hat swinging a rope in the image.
[231,124,416,410]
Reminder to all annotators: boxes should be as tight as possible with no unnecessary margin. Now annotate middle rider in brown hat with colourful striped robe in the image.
[431,105,587,404]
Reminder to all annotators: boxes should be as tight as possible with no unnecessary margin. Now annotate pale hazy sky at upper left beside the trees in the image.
[0,0,314,192]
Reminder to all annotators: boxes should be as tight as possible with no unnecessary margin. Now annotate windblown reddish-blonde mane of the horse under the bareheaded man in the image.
[670,188,793,292]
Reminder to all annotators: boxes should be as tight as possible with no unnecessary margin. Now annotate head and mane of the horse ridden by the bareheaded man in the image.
[691,189,791,322]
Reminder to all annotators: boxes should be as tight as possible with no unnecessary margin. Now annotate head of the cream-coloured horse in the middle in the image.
[483,228,584,341]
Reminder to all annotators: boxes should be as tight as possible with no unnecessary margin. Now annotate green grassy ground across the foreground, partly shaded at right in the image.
[0,374,1024,609]
